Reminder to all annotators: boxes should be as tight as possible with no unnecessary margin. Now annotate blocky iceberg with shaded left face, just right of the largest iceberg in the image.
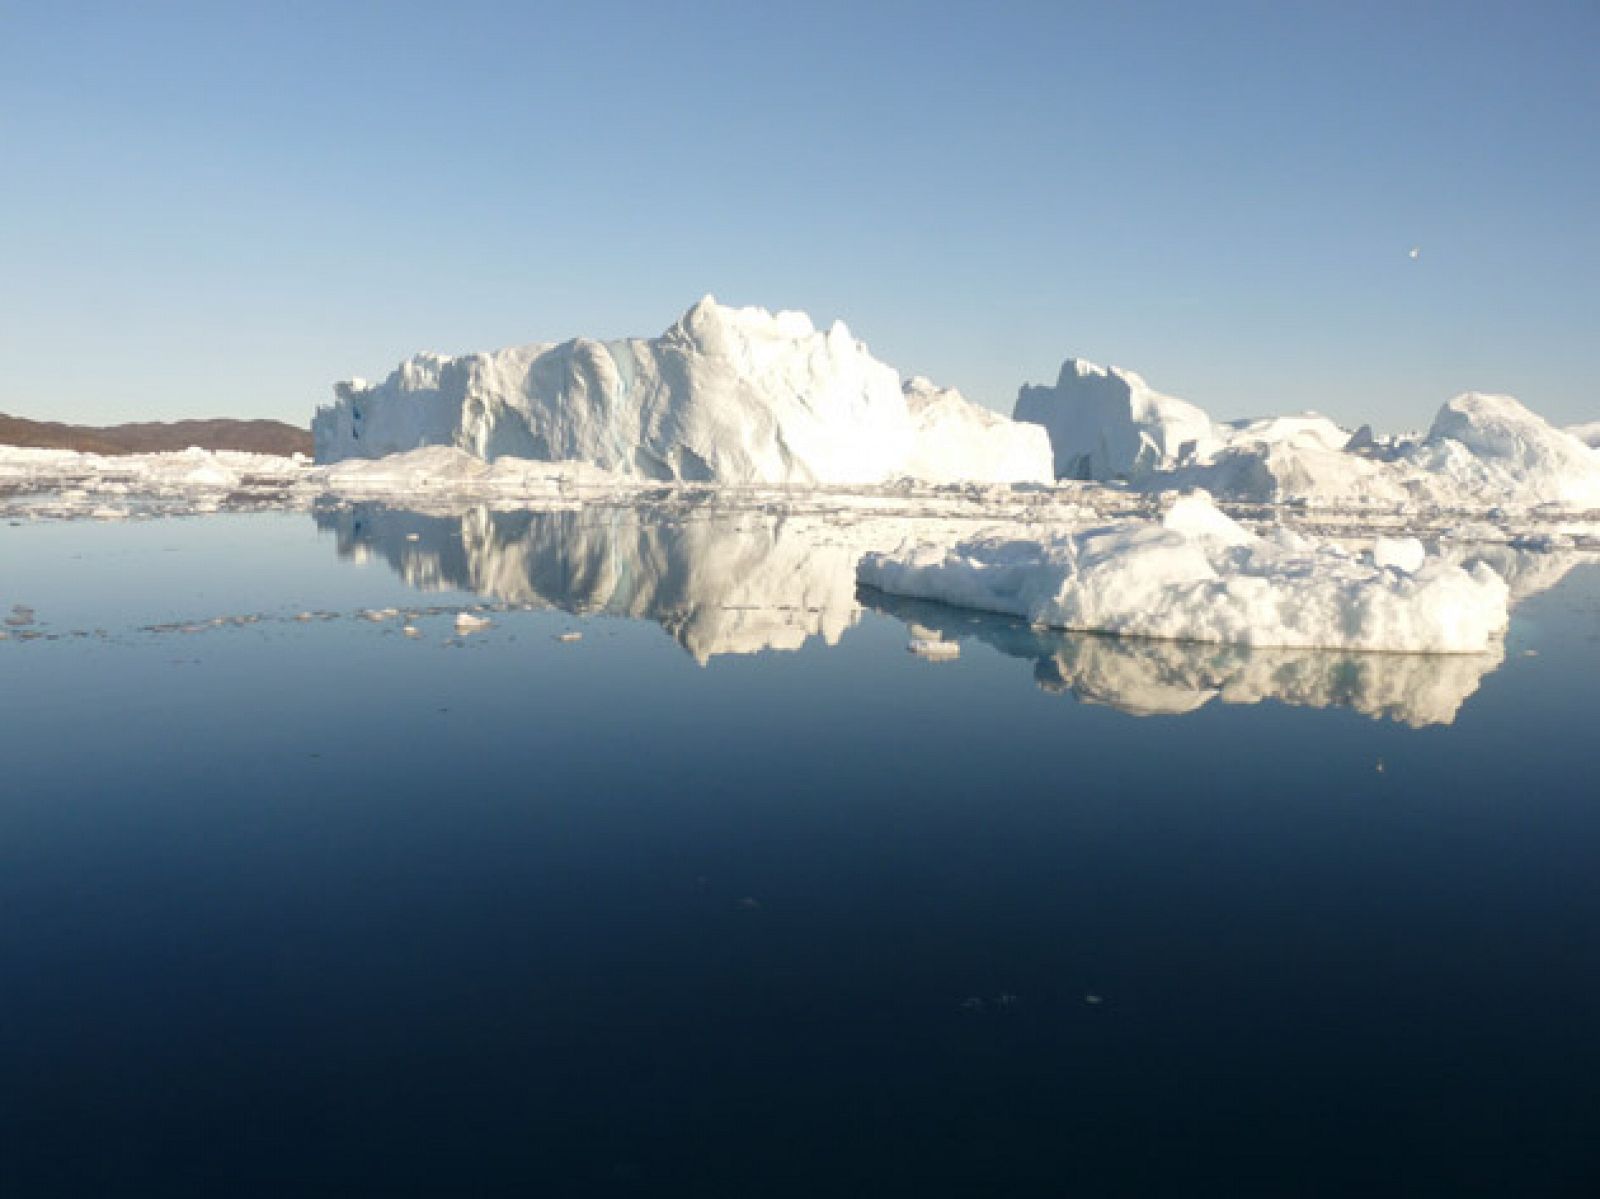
[1014,359,1218,480]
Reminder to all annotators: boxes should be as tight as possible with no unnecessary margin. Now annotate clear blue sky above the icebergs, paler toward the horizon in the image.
[0,0,1600,431]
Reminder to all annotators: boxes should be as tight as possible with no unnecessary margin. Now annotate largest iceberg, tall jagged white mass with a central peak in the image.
[312,296,1053,485]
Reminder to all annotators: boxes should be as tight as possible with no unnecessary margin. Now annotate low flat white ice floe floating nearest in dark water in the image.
[858,493,1509,653]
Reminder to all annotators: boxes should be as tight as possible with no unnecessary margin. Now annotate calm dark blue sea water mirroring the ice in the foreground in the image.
[0,509,1600,1196]
